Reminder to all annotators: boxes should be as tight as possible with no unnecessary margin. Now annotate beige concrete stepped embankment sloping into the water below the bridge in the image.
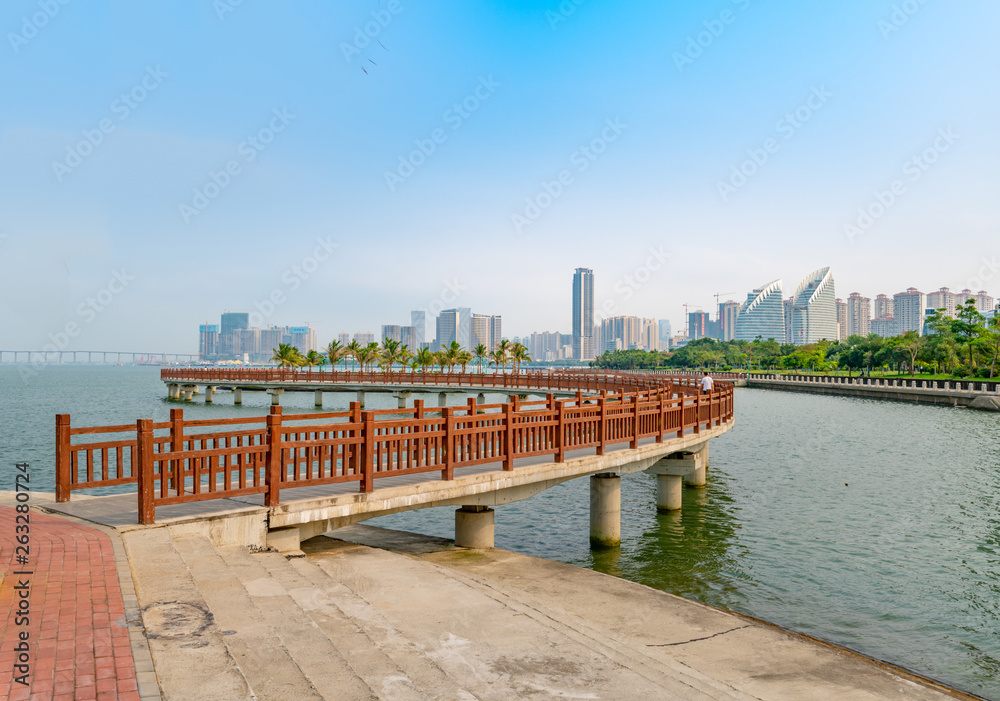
[115,526,968,701]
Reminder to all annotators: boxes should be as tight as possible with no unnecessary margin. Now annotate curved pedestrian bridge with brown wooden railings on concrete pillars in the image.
[51,368,734,552]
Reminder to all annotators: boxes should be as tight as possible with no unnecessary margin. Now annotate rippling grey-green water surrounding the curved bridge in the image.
[0,366,1000,698]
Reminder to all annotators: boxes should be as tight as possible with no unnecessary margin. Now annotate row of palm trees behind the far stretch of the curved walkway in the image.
[271,338,531,374]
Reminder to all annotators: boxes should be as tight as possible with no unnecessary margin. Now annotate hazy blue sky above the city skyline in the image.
[0,0,1000,352]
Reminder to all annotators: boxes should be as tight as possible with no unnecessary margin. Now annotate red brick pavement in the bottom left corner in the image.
[0,506,139,701]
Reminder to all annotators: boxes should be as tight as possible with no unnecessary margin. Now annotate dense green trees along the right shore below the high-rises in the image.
[591,301,1000,379]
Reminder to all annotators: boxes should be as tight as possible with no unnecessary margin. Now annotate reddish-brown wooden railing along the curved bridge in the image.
[56,369,733,523]
